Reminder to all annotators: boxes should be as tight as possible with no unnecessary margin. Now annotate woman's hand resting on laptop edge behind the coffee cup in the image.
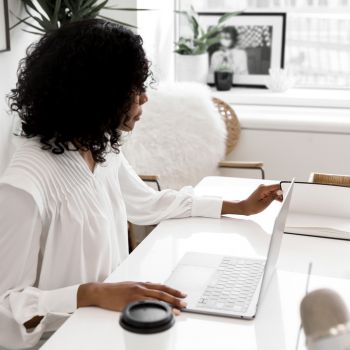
[77,282,187,313]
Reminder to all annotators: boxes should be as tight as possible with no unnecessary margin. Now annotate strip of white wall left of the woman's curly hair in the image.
[0,0,38,174]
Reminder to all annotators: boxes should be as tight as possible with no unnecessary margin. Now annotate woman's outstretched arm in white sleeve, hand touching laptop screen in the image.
[119,154,282,225]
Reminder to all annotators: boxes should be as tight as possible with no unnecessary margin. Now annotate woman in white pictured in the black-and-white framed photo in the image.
[210,26,249,75]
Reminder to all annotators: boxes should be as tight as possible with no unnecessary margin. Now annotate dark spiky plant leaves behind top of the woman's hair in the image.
[11,0,146,35]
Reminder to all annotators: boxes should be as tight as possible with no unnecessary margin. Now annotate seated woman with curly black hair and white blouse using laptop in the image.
[0,19,281,348]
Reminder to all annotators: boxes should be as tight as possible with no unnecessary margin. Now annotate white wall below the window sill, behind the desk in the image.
[223,129,350,181]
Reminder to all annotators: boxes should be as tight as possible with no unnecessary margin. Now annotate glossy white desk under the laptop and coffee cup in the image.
[42,177,350,350]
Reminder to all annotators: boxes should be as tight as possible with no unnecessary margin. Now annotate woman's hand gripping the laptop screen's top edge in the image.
[222,184,283,215]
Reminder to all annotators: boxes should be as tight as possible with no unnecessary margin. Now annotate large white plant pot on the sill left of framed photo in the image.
[176,52,209,84]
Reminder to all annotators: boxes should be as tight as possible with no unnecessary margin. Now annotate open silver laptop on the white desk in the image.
[166,180,294,319]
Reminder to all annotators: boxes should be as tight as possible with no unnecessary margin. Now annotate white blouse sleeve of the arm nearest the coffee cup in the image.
[0,184,78,348]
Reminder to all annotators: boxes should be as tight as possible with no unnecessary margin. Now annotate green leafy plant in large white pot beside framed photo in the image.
[175,6,240,83]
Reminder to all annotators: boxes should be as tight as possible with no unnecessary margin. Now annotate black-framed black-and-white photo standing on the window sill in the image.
[199,12,286,88]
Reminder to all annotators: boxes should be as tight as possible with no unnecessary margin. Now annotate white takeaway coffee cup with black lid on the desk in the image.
[119,300,175,350]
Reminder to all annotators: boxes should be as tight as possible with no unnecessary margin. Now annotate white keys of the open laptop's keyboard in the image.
[197,257,265,313]
